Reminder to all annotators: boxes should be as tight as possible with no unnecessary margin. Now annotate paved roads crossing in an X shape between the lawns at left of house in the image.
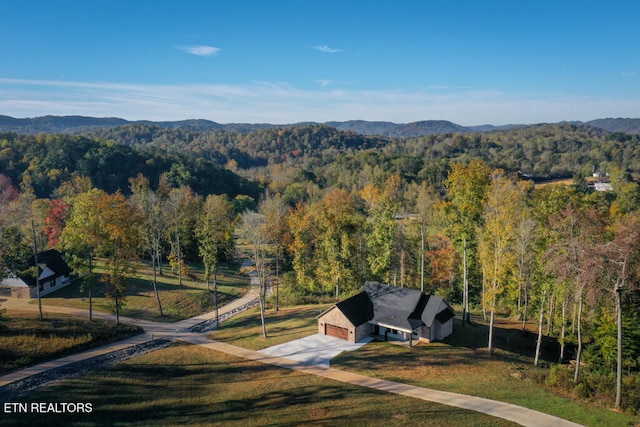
[0,292,580,427]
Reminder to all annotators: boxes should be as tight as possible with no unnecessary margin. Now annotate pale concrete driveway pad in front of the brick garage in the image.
[260,334,371,367]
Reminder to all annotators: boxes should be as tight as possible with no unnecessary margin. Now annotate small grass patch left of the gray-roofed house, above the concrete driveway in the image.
[209,304,330,350]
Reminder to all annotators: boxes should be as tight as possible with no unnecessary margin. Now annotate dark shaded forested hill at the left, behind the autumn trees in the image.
[0,133,261,200]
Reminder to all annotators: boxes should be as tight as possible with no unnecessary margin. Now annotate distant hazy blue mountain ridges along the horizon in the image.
[5,115,640,137]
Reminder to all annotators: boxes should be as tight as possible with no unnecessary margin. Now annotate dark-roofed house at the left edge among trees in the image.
[0,249,72,298]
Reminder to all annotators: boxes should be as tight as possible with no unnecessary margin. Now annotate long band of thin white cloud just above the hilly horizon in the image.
[0,78,640,125]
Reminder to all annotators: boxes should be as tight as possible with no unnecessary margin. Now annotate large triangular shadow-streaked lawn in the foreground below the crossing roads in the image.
[2,344,515,427]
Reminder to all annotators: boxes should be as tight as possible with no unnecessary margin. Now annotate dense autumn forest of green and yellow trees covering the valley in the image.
[0,124,640,409]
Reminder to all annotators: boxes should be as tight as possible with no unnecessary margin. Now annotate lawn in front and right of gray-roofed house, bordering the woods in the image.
[331,319,640,426]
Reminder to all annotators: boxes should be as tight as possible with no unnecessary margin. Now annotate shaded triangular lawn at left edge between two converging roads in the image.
[0,311,142,373]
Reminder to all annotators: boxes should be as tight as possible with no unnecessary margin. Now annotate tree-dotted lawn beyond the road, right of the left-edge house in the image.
[36,264,249,322]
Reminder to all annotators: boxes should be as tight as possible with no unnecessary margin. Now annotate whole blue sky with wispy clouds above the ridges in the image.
[0,0,640,125]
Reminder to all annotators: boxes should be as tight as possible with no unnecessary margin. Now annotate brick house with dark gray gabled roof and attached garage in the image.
[318,282,455,345]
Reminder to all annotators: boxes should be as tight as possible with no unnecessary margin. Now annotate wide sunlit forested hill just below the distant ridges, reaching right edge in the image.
[84,124,640,185]
